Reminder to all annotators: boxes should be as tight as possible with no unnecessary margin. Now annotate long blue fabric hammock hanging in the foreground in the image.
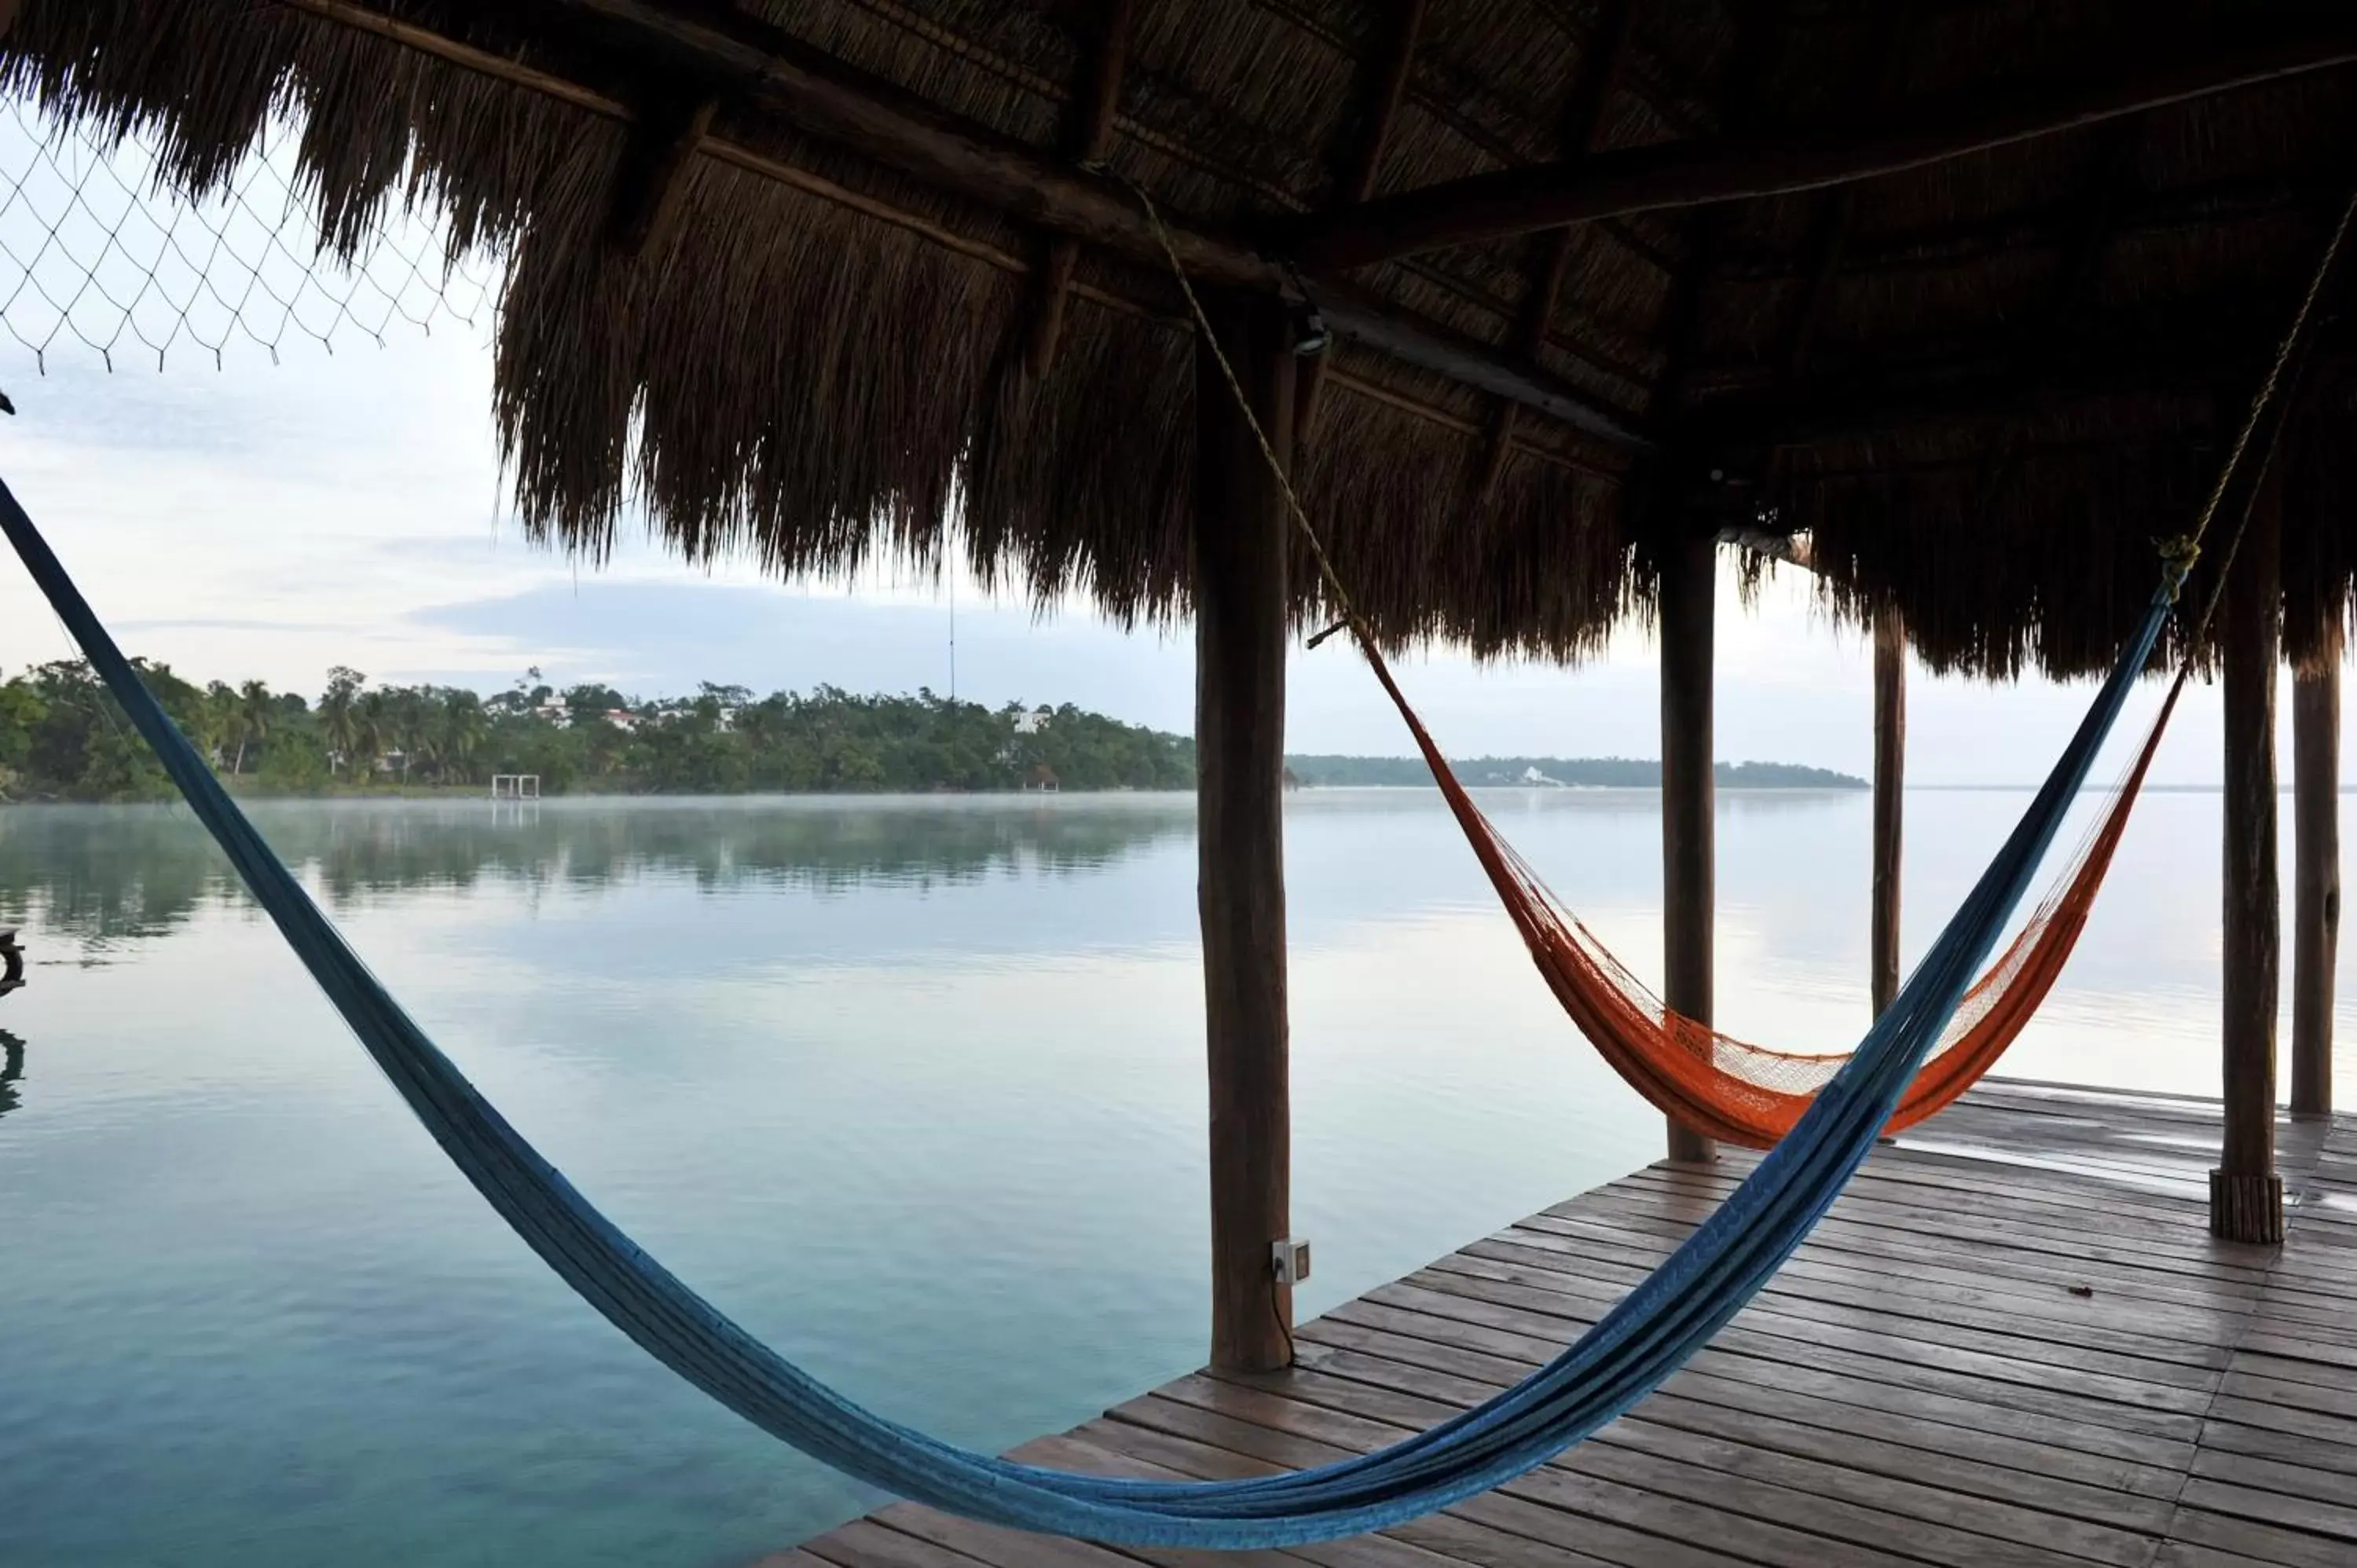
[0,485,2183,1549]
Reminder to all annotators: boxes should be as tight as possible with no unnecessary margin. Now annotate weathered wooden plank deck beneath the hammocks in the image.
[768,1083,2357,1568]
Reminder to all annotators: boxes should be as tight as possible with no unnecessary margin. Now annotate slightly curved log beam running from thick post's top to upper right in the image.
[1287,24,2357,269]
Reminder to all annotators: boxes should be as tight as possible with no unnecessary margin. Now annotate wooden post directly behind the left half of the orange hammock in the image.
[1662,533,1718,1160]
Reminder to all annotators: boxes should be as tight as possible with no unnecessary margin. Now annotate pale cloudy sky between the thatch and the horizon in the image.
[0,118,2319,786]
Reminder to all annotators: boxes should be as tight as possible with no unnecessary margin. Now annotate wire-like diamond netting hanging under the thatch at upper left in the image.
[0,101,495,370]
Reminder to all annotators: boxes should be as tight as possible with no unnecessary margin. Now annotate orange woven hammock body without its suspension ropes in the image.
[1367,646,2185,1149]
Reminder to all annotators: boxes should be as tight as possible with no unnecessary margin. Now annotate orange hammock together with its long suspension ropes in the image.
[1124,179,2357,1149]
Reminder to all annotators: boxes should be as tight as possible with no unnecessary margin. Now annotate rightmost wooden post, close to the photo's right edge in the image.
[2291,639,2341,1118]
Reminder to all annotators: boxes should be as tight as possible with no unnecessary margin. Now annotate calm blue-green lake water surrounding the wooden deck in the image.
[0,793,2357,1568]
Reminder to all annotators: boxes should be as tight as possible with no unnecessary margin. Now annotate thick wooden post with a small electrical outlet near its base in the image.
[1195,299,1296,1372]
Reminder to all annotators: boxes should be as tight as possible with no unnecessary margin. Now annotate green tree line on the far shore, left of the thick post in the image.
[0,660,1195,802]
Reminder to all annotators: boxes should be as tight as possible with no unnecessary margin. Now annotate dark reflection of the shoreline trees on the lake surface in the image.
[0,797,1195,948]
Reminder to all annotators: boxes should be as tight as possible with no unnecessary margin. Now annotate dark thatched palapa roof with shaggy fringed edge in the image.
[0,0,2357,674]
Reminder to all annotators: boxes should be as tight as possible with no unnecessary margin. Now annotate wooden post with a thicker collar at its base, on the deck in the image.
[2211,478,2284,1243]
